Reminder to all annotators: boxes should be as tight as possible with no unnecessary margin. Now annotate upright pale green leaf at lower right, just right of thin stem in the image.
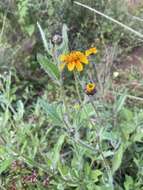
[112,144,124,174]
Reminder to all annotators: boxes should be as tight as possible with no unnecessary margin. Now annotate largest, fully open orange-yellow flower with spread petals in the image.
[60,51,89,72]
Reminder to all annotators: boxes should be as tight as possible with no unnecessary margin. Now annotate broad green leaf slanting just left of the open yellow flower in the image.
[37,54,60,85]
